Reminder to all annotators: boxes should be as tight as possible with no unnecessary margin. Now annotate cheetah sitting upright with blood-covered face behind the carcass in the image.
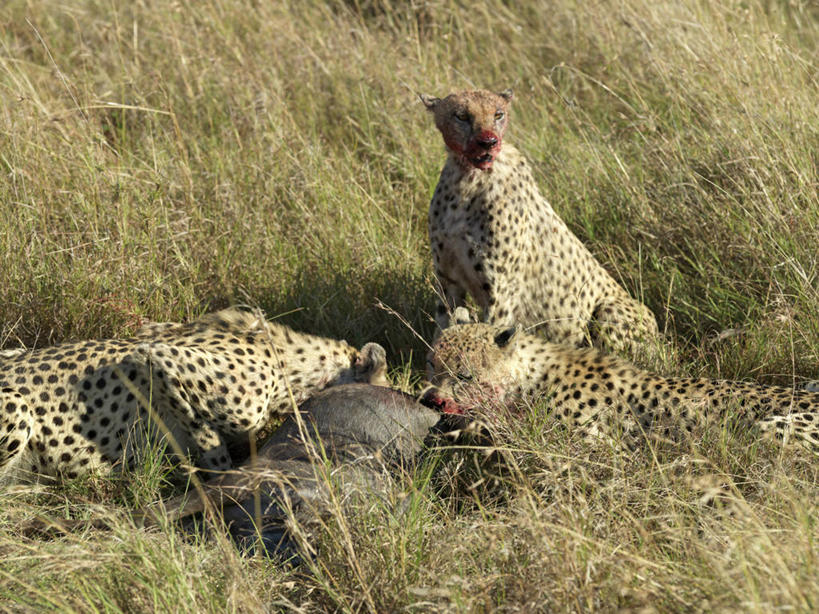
[421,90,658,352]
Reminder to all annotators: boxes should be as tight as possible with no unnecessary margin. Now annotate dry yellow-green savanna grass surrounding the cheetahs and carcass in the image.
[0,0,819,612]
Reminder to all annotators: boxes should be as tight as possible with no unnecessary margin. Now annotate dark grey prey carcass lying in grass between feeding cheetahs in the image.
[24,383,441,558]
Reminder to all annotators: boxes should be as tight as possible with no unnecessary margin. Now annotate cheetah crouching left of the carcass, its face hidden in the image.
[0,308,386,479]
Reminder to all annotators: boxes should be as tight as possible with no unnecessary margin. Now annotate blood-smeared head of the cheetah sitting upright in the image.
[421,90,512,171]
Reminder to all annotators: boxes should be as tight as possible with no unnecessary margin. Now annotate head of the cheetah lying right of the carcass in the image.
[423,323,518,414]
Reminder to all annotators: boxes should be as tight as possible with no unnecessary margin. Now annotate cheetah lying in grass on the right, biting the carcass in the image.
[425,310,819,452]
